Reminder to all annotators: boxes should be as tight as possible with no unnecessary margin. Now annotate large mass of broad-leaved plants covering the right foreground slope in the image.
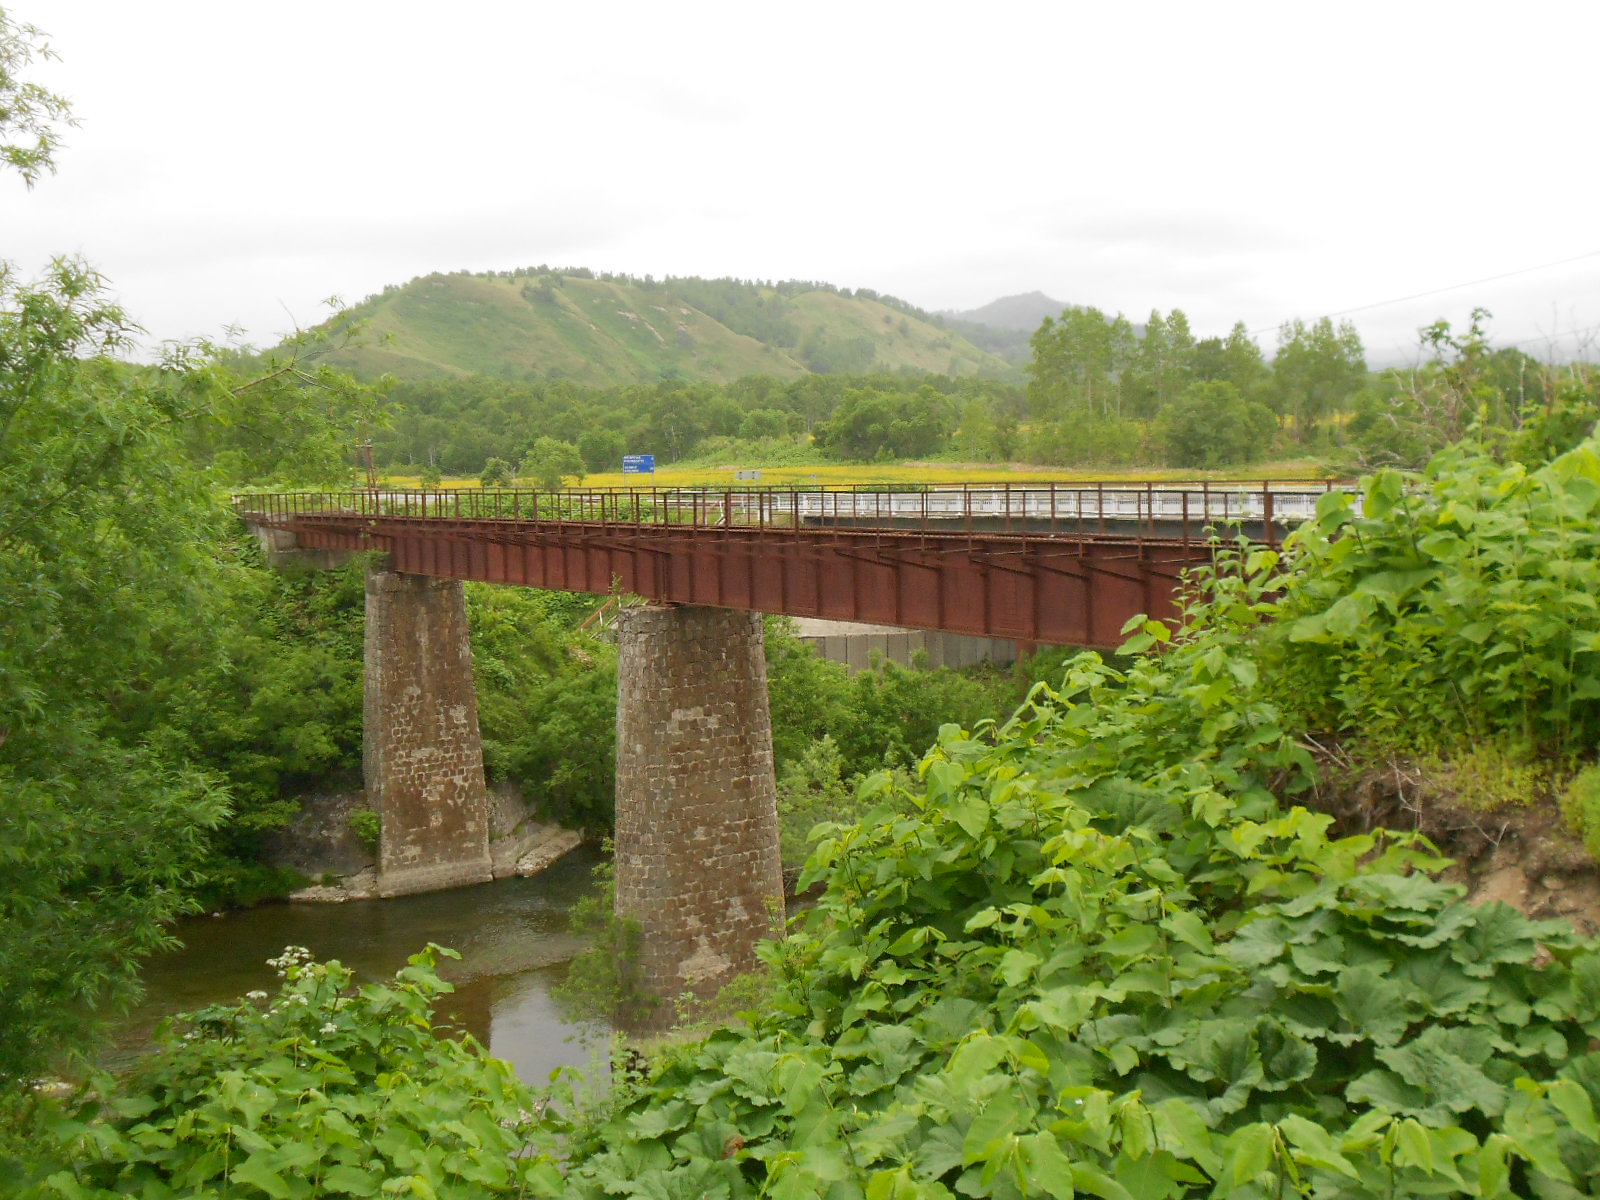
[550,662,1600,1200]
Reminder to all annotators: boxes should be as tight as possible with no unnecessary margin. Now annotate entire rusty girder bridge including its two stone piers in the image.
[234,482,1339,1024]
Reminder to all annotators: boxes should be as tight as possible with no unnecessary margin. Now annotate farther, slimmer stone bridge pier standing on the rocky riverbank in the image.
[362,570,491,896]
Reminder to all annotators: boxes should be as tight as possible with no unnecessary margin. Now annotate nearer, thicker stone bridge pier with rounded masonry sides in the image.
[616,606,782,1024]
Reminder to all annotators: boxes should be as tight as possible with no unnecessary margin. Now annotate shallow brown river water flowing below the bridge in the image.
[107,848,606,1086]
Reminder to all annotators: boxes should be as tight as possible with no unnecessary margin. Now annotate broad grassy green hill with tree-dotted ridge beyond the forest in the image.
[331,269,1016,387]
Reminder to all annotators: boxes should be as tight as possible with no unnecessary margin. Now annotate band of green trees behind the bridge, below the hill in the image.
[373,307,1590,483]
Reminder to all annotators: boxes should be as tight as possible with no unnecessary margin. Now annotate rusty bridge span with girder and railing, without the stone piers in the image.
[235,483,1333,646]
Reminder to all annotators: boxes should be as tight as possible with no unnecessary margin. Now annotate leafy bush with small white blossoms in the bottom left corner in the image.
[13,946,560,1200]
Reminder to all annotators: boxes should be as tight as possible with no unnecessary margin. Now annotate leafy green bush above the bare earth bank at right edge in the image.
[1261,438,1600,758]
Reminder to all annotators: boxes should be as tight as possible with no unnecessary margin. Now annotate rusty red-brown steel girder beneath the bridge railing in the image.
[256,512,1210,646]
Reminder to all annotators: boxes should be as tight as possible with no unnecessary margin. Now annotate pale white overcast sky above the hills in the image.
[0,0,1600,366]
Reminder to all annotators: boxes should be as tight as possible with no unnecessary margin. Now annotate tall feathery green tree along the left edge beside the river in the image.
[0,262,227,1085]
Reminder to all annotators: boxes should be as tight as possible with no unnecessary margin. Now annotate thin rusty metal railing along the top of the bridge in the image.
[234,480,1350,544]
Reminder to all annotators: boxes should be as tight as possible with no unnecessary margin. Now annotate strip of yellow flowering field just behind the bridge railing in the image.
[384,459,1326,488]
